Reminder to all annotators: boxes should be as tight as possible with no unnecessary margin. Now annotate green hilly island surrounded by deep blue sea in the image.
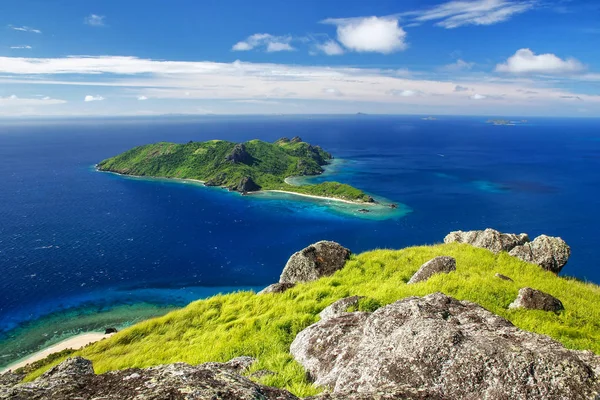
[97,137,374,203]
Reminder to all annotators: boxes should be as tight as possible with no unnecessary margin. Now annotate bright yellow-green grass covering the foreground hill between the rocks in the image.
[22,244,600,396]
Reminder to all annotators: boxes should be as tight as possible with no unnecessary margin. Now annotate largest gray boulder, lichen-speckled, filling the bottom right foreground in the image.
[290,293,600,400]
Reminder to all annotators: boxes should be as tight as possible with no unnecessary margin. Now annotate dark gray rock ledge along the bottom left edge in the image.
[0,357,297,400]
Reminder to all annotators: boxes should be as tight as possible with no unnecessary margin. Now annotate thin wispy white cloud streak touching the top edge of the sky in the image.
[401,0,536,29]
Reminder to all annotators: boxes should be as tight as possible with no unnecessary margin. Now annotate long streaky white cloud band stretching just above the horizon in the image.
[0,56,600,115]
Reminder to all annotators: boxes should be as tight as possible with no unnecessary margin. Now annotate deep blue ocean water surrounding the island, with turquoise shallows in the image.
[0,116,600,366]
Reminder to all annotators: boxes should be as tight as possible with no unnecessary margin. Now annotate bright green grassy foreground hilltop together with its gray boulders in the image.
[8,230,600,400]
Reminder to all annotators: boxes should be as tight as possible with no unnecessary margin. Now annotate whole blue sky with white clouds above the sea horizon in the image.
[0,0,600,117]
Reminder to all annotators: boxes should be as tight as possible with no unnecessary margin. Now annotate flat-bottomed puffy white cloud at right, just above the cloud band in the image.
[496,49,585,75]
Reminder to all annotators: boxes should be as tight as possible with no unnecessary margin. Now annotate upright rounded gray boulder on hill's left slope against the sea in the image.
[279,240,351,283]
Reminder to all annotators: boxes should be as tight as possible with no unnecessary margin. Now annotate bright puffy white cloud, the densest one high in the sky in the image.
[322,17,407,54]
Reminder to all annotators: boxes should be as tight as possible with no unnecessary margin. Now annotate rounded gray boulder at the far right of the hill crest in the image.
[509,235,571,274]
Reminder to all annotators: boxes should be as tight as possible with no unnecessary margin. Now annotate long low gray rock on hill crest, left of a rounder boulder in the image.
[444,228,529,253]
